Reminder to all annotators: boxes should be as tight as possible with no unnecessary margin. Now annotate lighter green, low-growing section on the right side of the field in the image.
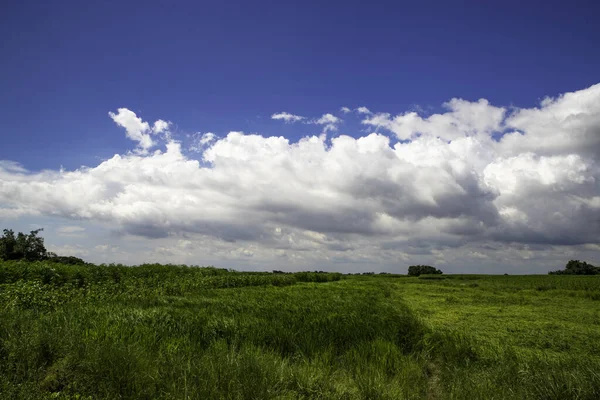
[396,275,600,399]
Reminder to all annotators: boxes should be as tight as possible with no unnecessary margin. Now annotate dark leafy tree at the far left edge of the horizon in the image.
[0,229,47,261]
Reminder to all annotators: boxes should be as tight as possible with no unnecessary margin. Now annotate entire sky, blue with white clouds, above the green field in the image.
[0,0,600,274]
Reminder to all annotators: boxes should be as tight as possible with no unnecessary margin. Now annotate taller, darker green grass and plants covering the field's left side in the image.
[0,261,426,399]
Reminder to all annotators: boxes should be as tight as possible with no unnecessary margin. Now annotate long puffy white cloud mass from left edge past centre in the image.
[1,132,494,240]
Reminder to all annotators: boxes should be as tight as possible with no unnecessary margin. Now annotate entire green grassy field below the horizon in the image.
[0,262,600,399]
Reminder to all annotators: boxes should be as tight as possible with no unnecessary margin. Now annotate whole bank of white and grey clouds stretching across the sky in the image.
[0,85,600,268]
